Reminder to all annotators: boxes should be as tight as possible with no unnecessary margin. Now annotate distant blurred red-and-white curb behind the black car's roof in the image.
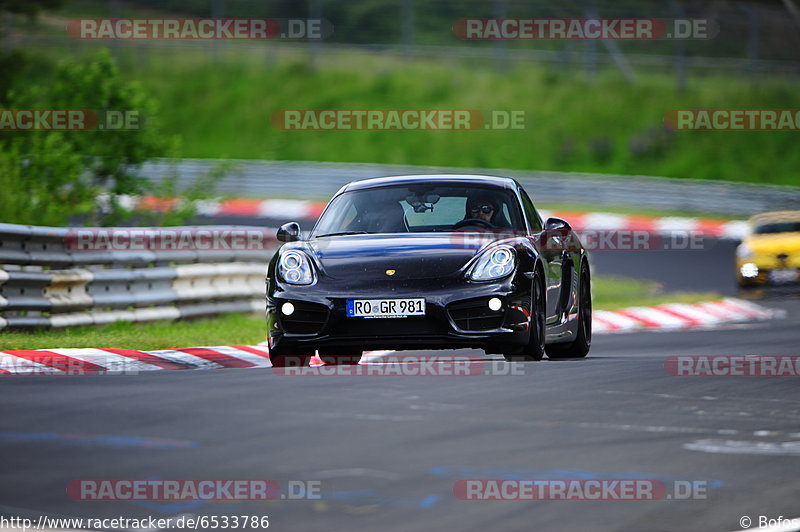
[121,196,747,240]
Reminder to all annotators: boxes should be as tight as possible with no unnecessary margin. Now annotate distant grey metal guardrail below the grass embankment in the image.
[140,159,800,216]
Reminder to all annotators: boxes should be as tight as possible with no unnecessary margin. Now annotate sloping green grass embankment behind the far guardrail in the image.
[125,48,800,185]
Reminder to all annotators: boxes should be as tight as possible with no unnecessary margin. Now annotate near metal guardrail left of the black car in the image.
[0,224,276,330]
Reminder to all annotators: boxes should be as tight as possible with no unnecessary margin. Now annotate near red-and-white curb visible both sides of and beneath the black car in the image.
[0,298,777,375]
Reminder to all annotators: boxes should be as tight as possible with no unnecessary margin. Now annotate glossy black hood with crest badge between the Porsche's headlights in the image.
[306,233,480,280]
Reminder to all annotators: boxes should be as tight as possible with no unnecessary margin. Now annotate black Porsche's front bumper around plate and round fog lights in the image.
[267,278,531,351]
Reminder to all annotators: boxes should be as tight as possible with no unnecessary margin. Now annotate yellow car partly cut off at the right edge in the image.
[736,211,800,287]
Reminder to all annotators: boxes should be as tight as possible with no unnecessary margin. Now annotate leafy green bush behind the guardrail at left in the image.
[0,50,169,225]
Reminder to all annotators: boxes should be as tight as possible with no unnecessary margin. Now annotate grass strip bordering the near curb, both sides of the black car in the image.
[0,277,720,351]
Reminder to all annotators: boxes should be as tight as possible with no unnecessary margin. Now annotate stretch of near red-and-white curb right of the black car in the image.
[592,298,778,334]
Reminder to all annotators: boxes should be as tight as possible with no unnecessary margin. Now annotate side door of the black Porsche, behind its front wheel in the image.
[519,187,565,324]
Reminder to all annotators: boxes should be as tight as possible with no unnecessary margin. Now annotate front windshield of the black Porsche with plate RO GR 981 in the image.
[312,183,525,237]
